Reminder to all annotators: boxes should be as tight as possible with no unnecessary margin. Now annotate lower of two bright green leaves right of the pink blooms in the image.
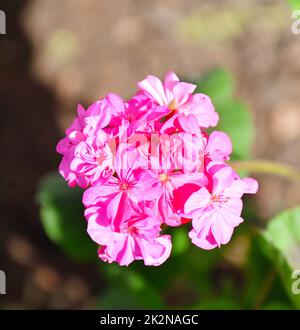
[215,100,254,159]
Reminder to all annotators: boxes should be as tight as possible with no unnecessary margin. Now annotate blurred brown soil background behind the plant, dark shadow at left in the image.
[0,0,300,308]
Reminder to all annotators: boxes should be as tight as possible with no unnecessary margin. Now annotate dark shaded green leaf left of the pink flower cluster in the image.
[37,173,97,261]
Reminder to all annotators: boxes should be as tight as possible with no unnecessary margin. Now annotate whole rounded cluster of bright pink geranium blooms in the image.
[57,72,258,266]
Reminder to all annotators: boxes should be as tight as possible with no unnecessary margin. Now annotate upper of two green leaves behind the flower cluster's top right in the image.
[196,68,235,106]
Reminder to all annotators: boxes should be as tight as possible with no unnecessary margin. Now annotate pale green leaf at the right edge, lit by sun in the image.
[260,207,300,308]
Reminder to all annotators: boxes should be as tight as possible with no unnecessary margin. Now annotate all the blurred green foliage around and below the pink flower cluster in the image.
[37,69,300,309]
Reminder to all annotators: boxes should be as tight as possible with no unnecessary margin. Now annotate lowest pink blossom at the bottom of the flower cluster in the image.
[86,208,172,266]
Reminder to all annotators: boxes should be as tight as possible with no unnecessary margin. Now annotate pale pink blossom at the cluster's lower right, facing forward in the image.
[184,164,258,250]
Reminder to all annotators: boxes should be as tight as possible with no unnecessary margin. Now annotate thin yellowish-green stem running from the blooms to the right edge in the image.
[230,159,300,181]
